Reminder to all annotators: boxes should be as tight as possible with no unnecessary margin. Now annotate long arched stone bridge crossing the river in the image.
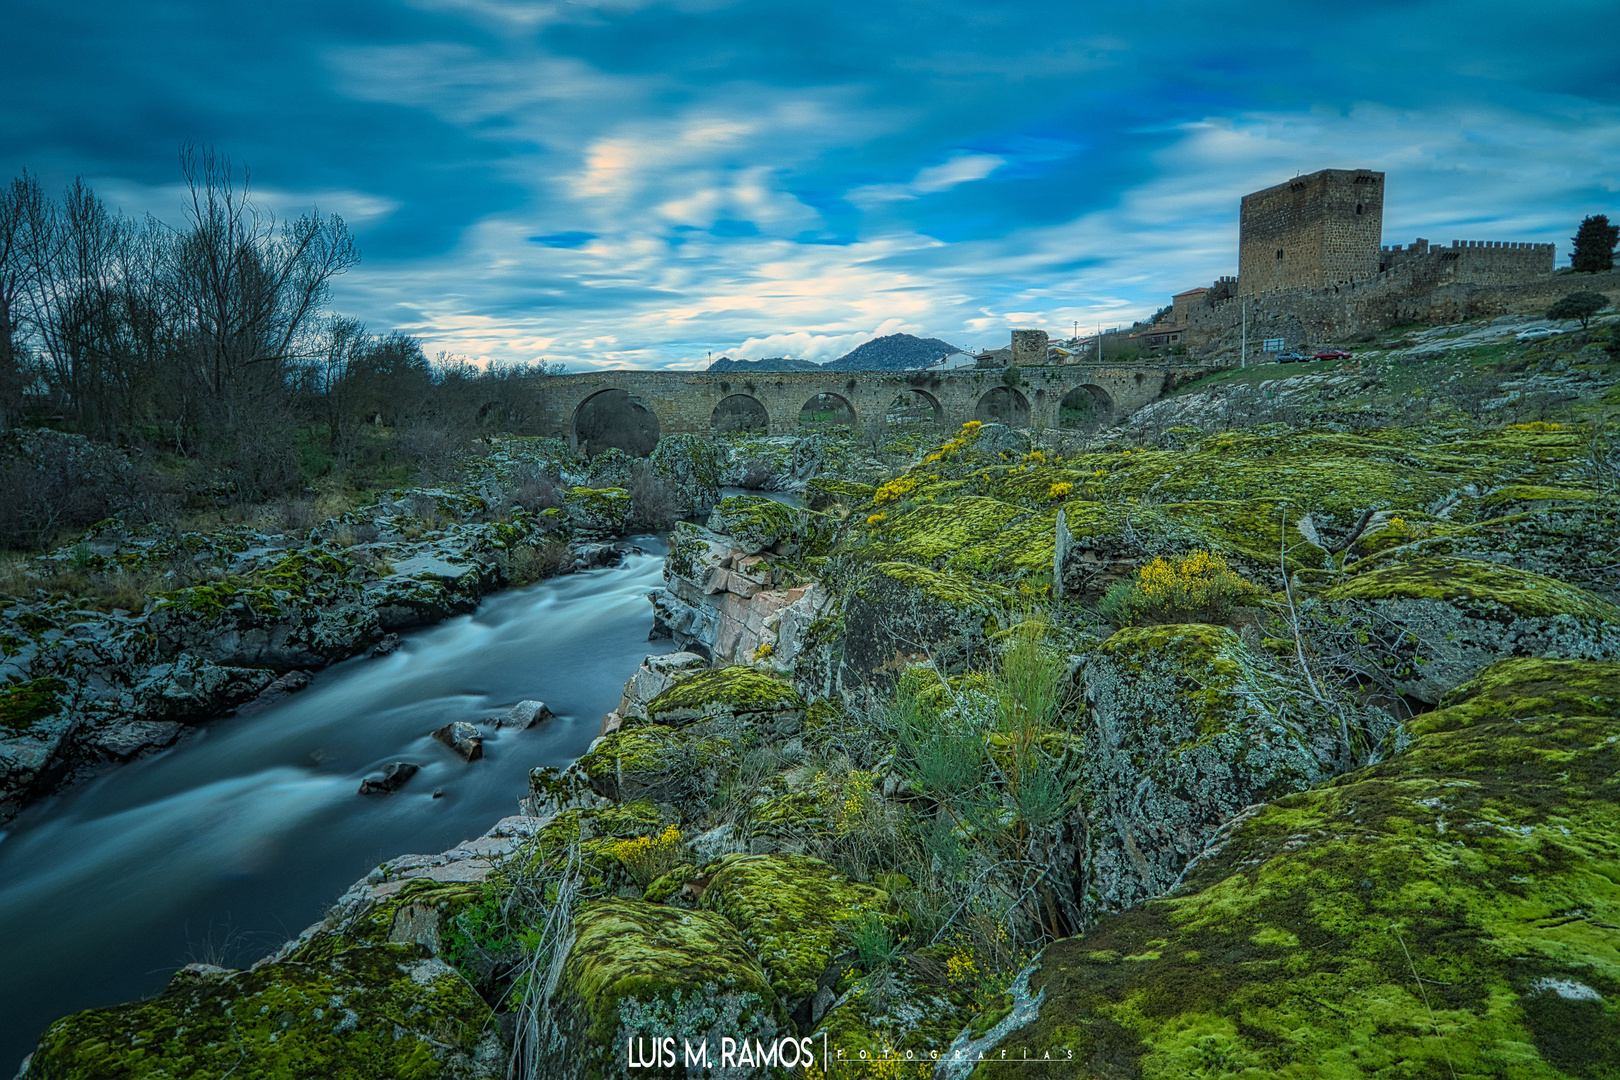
[543,364,1215,453]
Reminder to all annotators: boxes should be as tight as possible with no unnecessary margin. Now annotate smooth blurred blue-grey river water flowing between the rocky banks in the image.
[0,538,671,1075]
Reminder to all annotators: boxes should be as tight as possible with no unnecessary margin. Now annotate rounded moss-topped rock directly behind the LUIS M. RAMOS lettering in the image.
[559,900,779,1078]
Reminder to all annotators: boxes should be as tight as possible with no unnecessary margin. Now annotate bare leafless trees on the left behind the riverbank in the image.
[0,147,567,502]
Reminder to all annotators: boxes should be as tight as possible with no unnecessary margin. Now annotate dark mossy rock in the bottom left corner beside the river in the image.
[23,941,492,1080]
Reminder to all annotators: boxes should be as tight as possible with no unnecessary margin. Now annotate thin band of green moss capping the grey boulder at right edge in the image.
[1324,559,1620,623]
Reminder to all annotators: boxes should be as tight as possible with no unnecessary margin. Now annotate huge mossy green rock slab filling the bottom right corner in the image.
[974,659,1620,1080]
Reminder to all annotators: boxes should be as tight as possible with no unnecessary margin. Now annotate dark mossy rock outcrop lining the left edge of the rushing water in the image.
[0,484,609,818]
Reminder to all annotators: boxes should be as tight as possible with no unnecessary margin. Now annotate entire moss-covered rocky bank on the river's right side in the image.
[12,325,1620,1077]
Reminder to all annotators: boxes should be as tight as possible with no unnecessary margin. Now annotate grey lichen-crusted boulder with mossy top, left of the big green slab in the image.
[1082,623,1392,912]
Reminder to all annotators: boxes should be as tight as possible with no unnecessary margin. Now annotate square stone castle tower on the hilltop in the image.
[1238,168,1383,296]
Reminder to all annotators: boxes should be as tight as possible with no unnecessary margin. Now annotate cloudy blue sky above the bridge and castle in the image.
[0,0,1620,369]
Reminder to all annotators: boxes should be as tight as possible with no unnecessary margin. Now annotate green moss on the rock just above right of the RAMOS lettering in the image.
[700,855,888,1007]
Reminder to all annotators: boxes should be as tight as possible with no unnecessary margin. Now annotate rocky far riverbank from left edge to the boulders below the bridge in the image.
[0,436,881,821]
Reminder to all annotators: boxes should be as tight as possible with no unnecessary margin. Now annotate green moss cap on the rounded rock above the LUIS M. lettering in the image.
[562,900,776,1044]
